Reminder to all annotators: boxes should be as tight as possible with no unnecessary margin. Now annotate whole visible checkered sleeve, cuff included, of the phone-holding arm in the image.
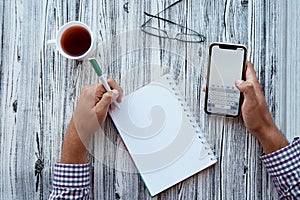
[260,138,300,199]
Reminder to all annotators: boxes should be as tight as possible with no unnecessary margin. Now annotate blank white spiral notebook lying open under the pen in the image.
[109,74,216,196]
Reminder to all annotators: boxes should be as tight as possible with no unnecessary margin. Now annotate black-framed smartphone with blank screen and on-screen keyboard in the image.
[204,43,247,117]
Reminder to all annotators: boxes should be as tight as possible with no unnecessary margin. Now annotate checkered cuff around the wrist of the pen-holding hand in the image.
[53,163,90,188]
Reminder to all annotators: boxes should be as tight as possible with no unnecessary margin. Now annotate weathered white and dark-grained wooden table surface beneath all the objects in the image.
[0,0,300,200]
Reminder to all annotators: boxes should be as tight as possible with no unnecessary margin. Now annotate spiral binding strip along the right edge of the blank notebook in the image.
[166,74,217,160]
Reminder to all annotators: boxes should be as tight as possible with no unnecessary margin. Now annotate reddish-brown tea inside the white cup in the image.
[61,26,92,56]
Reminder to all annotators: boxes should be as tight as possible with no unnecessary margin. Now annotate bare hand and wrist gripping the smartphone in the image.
[235,62,289,154]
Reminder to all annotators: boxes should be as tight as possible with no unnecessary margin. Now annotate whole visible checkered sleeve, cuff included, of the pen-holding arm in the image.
[49,163,90,199]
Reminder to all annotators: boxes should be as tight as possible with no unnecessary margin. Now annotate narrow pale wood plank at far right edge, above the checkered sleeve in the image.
[277,1,300,141]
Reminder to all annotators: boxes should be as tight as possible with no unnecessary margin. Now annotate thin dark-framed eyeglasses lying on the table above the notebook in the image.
[141,0,206,43]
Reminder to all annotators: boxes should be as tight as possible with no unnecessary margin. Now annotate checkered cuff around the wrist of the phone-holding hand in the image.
[260,138,300,176]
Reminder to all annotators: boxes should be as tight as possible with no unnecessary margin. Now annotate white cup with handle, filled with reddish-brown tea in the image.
[47,21,96,60]
